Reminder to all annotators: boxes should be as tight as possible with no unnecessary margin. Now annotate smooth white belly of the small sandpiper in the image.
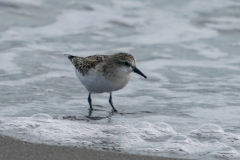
[75,70,131,93]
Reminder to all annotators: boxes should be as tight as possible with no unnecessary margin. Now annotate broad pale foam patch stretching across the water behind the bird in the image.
[0,1,218,44]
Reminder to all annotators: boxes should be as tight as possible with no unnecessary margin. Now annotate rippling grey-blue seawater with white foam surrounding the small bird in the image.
[0,0,240,159]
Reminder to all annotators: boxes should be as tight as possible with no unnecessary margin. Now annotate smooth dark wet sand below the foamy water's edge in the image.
[0,135,184,160]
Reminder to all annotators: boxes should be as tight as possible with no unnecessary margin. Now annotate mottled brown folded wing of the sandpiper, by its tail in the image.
[68,55,108,75]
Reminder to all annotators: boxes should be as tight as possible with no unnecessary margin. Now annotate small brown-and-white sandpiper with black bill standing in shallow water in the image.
[68,53,147,112]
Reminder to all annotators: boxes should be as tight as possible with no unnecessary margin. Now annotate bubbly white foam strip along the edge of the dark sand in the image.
[0,113,240,158]
